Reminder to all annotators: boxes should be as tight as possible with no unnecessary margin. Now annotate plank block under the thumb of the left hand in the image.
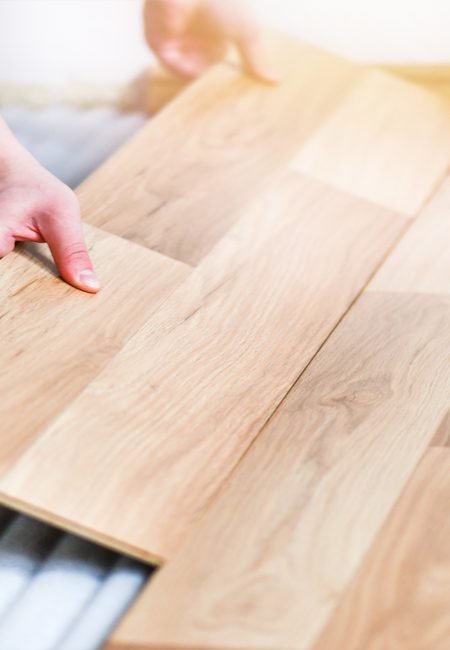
[0,226,190,474]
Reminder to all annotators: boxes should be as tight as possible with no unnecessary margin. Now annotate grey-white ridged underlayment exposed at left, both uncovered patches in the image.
[0,107,151,650]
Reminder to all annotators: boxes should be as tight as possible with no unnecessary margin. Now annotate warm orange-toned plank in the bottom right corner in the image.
[314,448,450,650]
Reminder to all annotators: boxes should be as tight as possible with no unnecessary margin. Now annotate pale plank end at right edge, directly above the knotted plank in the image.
[370,178,450,295]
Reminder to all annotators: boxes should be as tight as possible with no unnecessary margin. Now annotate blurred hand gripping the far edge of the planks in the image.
[144,0,276,83]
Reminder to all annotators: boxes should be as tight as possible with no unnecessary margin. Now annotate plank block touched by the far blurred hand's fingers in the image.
[79,37,366,264]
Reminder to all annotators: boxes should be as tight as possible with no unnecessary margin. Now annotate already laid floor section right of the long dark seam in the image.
[110,167,450,650]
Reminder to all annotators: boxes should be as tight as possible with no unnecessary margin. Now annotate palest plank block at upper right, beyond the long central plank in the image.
[293,71,450,215]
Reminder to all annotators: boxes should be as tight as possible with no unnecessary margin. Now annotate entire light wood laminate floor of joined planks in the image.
[0,33,450,650]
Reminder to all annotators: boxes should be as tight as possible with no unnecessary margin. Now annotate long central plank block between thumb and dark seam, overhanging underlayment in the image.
[0,173,405,561]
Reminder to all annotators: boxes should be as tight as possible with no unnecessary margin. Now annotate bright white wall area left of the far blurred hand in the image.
[0,0,149,84]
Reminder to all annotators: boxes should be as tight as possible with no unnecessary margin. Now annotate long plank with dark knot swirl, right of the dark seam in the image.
[108,292,450,650]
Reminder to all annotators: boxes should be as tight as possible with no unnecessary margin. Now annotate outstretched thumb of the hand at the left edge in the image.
[39,202,100,293]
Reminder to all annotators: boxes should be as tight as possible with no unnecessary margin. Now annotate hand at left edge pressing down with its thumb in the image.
[0,121,100,293]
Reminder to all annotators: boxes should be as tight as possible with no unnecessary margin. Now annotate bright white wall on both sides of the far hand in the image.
[0,0,450,86]
